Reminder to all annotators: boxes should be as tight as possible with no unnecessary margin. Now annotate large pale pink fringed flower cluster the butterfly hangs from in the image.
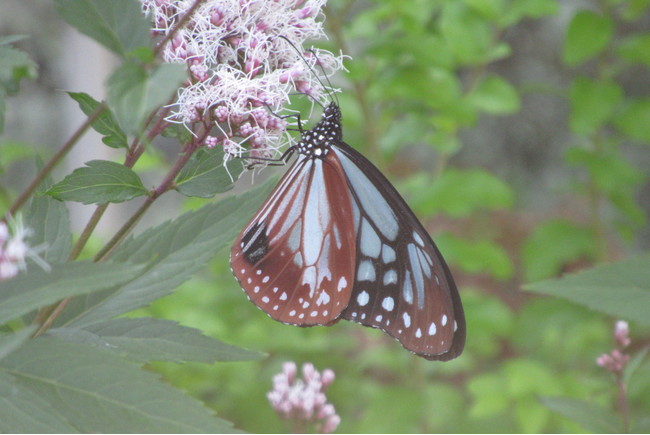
[141,0,343,157]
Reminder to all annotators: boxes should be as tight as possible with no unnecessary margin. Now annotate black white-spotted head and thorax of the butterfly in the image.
[297,102,343,157]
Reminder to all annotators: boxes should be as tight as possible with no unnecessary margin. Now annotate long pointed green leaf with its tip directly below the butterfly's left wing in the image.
[48,318,263,363]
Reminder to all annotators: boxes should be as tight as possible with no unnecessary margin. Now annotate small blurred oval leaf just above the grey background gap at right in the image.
[468,76,519,115]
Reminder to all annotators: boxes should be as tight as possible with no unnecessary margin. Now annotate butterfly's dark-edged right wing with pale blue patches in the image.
[332,142,465,361]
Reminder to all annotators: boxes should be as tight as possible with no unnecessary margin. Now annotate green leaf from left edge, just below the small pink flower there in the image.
[0,261,142,324]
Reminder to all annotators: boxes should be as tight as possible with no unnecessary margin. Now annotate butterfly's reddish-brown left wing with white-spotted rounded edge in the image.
[230,153,356,326]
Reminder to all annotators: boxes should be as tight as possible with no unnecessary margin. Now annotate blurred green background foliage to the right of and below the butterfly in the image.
[129,0,650,433]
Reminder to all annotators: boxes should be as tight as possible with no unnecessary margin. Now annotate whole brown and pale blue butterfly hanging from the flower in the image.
[230,102,466,361]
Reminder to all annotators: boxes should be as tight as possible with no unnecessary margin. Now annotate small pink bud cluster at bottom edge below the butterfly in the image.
[267,362,341,433]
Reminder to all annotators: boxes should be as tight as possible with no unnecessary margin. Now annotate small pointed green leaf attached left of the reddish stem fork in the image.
[46,160,148,204]
